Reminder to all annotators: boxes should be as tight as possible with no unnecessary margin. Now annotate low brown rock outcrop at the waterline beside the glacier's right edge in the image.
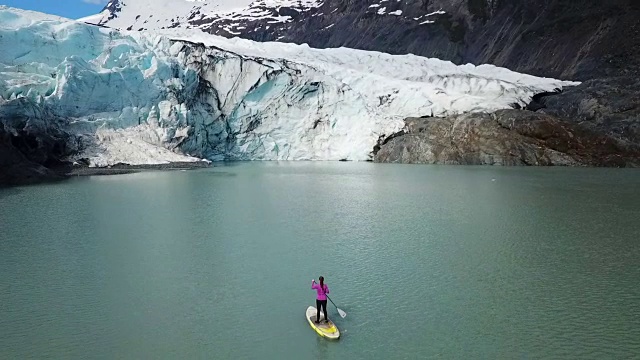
[375,110,640,167]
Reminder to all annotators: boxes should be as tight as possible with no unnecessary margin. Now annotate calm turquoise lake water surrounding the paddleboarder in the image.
[0,163,640,359]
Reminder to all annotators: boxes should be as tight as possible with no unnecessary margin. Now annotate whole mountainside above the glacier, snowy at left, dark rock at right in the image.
[92,0,640,80]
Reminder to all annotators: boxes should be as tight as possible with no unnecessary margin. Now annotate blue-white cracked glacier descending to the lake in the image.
[0,6,578,167]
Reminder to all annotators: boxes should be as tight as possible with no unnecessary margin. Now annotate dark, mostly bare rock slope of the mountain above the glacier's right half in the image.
[280,0,640,80]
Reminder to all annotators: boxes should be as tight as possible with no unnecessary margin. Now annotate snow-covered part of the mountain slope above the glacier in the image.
[79,0,446,52]
